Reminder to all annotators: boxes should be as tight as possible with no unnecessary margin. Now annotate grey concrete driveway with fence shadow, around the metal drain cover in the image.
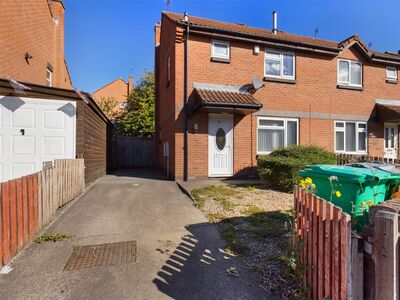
[0,170,267,299]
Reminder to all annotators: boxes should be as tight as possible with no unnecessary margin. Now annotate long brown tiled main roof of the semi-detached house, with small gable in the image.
[163,12,400,62]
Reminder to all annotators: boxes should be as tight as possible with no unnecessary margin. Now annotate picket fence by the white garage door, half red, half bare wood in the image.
[0,159,85,267]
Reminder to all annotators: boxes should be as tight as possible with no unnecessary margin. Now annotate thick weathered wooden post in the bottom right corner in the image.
[373,210,399,299]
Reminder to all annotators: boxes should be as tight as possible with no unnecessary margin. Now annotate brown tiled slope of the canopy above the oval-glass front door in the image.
[193,87,262,110]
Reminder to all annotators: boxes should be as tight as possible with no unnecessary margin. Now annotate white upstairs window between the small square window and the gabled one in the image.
[264,50,295,79]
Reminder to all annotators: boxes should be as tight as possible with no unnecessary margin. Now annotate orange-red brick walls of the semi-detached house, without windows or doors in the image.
[156,14,400,178]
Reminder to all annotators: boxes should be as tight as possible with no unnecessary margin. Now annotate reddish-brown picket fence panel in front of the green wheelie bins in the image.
[294,188,352,300]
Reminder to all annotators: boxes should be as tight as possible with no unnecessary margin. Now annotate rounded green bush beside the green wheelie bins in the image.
[257,146,337,192]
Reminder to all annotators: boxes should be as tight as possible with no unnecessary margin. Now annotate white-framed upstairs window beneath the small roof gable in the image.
[338,59,362,87]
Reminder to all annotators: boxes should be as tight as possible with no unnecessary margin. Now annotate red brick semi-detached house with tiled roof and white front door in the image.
[155,12,400,178]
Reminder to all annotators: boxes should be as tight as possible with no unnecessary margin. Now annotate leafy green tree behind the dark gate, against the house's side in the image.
[116,72,155,137]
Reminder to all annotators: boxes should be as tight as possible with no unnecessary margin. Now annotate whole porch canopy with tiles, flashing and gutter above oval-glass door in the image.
[192,84,262,115]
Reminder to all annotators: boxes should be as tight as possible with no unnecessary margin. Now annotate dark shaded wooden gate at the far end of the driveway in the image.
[113,136,155,169]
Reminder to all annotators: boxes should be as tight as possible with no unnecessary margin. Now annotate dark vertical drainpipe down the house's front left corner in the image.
[183,12,190,181]
